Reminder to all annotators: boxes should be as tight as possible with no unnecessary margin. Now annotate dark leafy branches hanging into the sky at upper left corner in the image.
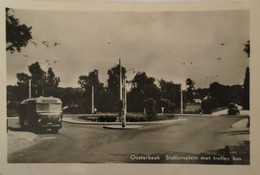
[5,8,32,53]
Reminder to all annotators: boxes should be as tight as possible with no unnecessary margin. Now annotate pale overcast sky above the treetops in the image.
[7,9,249,88]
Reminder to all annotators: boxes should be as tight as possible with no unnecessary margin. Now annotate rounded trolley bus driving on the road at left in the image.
[19,97,62,133]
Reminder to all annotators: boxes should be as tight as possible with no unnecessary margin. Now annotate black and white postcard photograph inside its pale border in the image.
[5,8,250,165]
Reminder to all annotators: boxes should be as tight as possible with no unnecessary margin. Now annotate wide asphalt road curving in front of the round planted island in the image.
[8,116,249,164]
